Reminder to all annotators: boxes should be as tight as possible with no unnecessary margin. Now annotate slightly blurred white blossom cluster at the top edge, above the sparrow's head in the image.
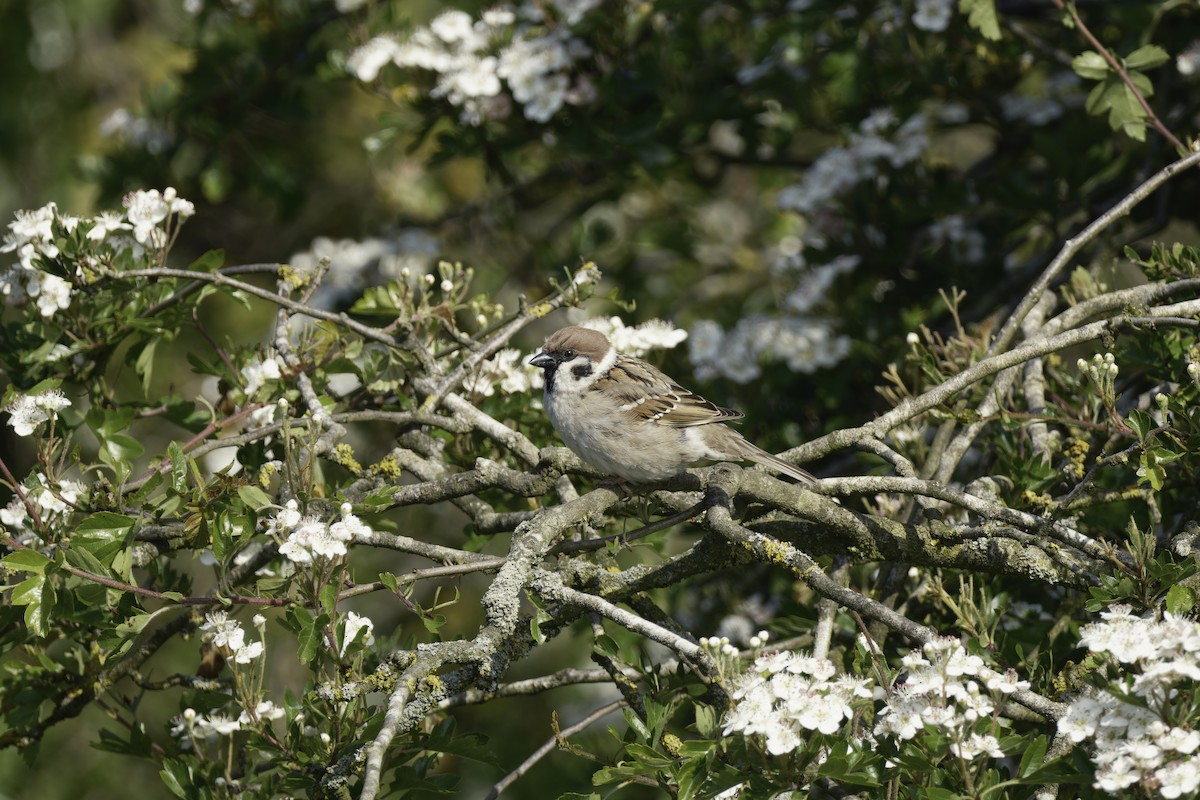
[346,0,599,125]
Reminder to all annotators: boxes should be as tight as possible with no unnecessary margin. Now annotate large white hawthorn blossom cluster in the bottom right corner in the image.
[1058,606,1200,800]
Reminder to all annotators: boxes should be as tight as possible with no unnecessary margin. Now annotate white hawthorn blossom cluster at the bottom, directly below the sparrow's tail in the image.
[725,650,874,756]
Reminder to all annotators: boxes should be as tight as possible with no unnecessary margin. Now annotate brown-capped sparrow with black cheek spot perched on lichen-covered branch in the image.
[529,326,816,483]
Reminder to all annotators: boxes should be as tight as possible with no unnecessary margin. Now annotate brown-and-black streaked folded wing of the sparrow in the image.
[592,355,744,428]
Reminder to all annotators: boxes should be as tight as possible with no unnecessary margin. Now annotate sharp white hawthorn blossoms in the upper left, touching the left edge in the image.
[0,188,196,319]
